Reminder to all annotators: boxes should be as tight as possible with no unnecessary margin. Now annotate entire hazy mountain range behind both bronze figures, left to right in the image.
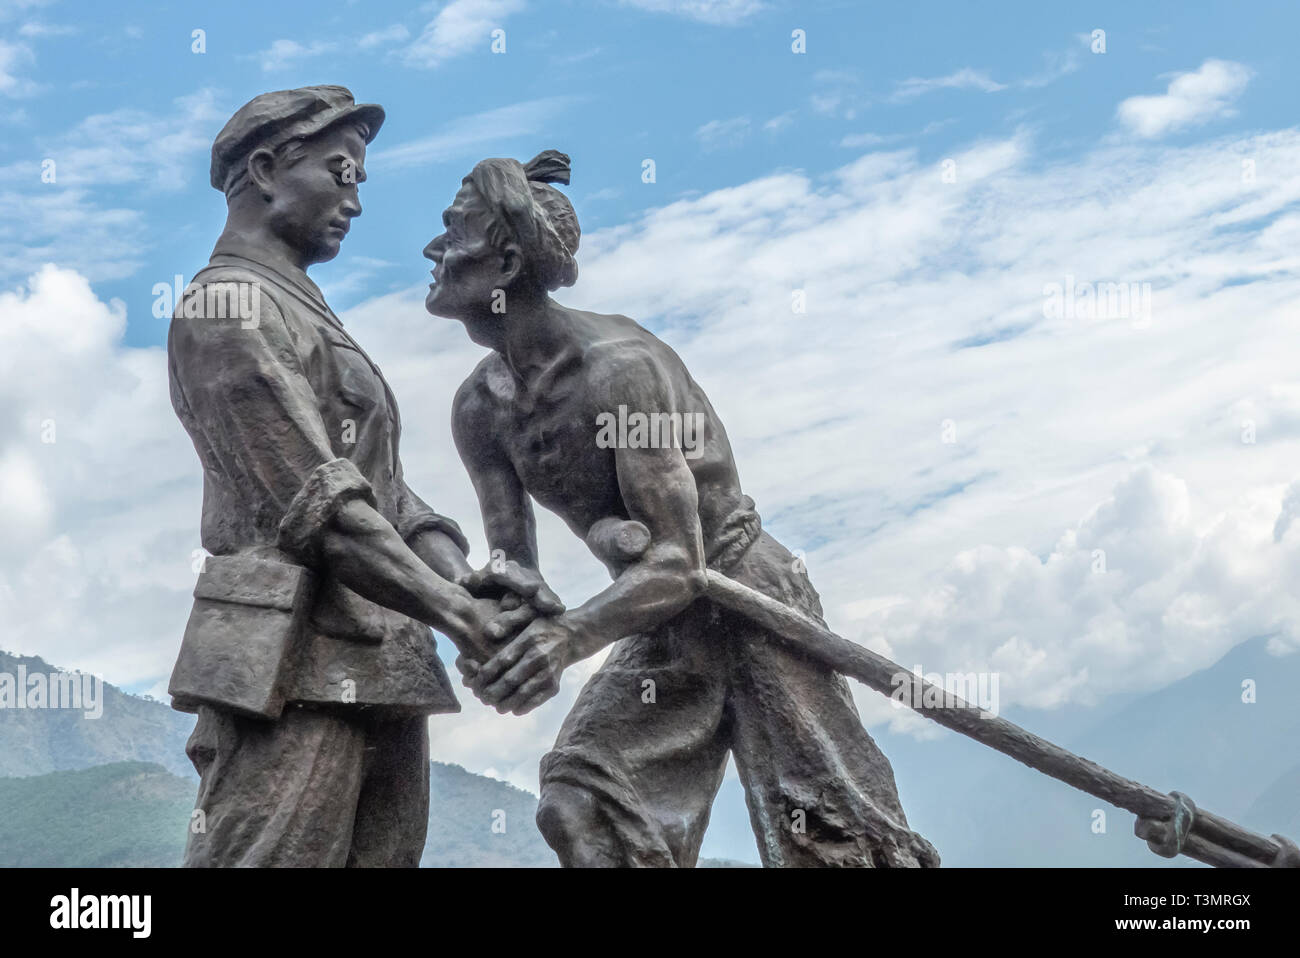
[0,638,1300,867]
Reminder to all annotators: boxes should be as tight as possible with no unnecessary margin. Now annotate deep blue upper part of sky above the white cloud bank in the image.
[0,0,1297,344]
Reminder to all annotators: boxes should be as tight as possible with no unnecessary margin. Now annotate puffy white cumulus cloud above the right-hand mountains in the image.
[863,467,1300,727]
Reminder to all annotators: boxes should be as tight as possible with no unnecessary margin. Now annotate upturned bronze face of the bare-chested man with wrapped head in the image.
[424,183,508,320]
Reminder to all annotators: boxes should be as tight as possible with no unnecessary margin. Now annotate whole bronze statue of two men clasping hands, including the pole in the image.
[157,95,1300,867]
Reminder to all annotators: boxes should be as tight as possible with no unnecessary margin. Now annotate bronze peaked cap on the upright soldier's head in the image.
[212,86,384,192]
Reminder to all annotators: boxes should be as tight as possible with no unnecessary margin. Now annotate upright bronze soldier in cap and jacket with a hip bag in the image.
[168,86,559,867]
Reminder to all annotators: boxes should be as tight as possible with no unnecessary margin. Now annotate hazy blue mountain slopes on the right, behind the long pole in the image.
[878,638,1300,867]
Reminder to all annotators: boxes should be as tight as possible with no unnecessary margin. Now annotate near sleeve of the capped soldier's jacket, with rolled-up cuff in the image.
[168,287,374,565]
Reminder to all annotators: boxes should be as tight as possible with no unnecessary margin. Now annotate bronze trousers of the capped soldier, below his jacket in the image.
[185,705,429,868]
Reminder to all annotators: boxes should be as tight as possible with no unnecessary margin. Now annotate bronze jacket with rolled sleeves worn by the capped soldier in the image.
[168,240,468,714]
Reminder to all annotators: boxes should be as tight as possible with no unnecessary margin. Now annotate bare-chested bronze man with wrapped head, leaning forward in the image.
[425,151,939,867]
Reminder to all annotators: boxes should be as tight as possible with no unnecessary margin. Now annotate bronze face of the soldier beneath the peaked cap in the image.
[269,123,365,266]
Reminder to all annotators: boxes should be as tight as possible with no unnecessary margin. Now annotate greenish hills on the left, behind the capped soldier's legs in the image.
[0,653,569,867]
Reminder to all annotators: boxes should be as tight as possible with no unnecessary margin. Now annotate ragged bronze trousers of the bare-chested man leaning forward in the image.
[538,533,939,867]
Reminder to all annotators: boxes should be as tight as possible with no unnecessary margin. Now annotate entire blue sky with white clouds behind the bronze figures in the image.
[0,0,1300,863]
